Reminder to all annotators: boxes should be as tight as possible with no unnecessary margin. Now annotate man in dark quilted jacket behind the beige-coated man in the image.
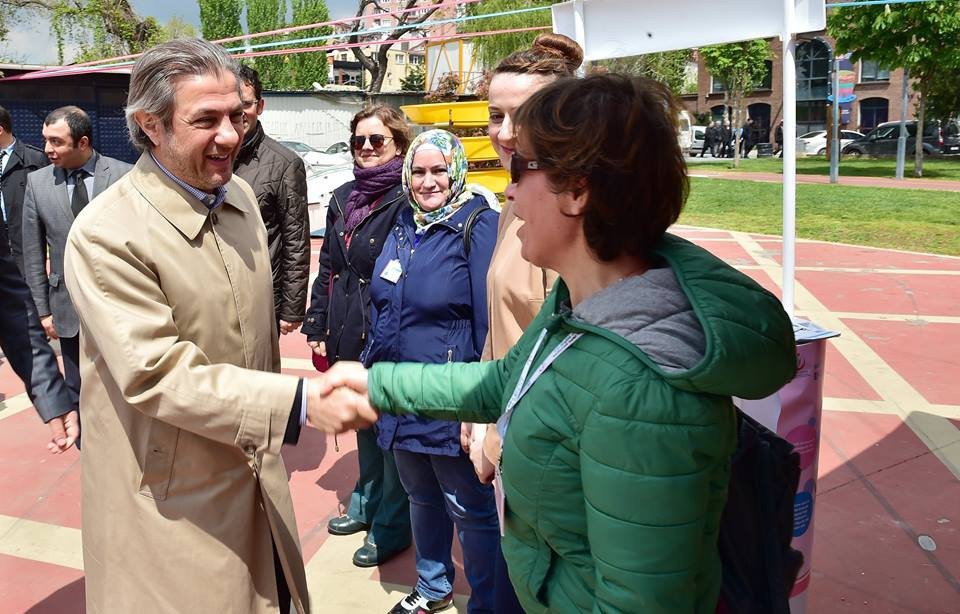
[233,66,310,335]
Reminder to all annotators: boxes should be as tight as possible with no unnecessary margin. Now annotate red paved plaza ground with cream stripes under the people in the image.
[0,229,960,614]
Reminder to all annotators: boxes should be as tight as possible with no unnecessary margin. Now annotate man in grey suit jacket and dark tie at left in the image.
[22,106,132,426]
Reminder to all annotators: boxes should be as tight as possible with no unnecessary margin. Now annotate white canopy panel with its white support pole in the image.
[552,0,827,316]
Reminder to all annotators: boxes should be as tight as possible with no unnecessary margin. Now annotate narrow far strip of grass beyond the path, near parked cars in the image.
[687,155,960,181]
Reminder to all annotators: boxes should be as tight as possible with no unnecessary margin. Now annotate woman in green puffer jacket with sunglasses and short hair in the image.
[327,75,795,614]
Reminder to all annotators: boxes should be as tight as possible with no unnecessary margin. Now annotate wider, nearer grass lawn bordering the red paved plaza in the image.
[679,176,960,256]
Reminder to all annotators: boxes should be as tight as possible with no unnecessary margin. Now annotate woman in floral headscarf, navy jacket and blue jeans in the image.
[363,130,499,614]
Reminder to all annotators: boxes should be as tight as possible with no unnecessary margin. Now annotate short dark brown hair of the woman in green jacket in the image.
[516,74,689,262]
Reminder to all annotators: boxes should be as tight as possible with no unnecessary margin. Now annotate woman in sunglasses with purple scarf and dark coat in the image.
[302,105,410,567]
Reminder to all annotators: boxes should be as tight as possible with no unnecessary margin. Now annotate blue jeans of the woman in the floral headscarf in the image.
[393,450,500,614]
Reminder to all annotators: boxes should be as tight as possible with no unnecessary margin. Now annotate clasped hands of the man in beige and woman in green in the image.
[307,361,380,433]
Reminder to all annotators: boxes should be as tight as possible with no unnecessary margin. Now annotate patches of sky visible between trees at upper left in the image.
[0,0,357,64]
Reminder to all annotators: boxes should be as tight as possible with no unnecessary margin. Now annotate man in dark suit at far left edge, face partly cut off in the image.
[0,107,50,273]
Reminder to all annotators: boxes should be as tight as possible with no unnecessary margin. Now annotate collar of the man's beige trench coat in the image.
[130,152,252,239]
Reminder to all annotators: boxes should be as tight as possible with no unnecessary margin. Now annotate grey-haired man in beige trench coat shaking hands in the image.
[65,40,376,614]
